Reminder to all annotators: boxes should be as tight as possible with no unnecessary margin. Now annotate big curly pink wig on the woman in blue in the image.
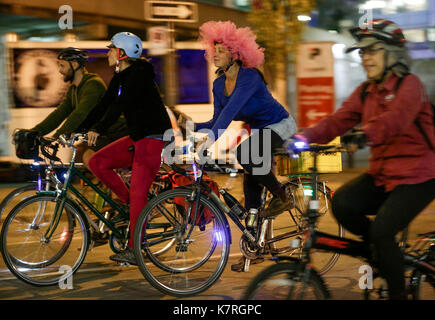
[199,21,264,68]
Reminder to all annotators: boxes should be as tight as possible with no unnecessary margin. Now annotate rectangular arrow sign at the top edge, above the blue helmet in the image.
[145,1,198,22]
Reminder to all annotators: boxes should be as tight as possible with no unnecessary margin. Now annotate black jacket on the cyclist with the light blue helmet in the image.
[91,60,172,141]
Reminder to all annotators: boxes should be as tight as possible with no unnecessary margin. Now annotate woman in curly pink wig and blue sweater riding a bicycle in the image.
[195,21,296,271]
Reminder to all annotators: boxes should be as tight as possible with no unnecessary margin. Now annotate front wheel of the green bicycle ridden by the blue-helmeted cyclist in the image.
[0,195,89,286]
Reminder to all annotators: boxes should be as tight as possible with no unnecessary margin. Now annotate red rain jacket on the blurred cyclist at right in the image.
[303,74,435,192]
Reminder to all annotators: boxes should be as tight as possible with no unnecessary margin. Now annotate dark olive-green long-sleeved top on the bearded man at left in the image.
[32,70,110,137]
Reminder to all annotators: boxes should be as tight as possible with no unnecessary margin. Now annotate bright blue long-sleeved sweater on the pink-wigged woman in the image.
[195,67,289,140]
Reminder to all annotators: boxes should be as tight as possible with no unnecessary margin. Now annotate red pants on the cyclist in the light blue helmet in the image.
[89,136,164,248]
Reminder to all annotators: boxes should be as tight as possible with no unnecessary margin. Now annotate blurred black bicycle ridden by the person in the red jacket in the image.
[243,144,435,300]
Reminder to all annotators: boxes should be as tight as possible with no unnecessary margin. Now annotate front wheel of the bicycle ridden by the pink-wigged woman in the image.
[134,188,230,297]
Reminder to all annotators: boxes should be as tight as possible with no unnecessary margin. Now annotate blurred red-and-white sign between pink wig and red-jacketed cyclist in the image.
[296,42,335,128]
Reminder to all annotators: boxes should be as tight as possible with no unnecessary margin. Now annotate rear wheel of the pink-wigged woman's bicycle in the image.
[268,177,344,275]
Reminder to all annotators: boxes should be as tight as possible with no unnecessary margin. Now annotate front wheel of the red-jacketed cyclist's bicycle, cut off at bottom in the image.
[242,262,330,300]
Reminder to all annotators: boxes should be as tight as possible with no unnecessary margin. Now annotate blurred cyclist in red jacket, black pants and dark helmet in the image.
[301,19,435,299]
